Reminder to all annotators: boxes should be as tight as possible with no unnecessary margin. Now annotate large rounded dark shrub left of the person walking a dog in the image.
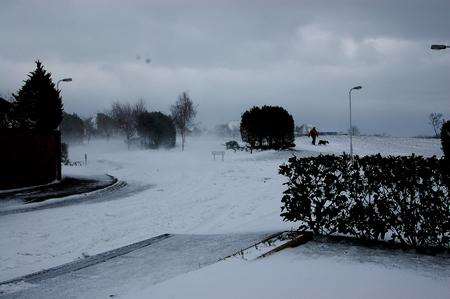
[240,106,295,149]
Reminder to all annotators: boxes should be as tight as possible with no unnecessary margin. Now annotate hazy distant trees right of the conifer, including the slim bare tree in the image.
[61,92,196,150]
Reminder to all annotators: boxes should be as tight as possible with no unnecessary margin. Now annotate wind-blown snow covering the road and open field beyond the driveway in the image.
[0,136,444,294]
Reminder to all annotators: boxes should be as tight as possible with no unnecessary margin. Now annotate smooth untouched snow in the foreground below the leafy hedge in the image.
[124,241,450,299]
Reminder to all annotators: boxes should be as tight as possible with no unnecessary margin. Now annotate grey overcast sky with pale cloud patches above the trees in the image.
[0,0,450,136]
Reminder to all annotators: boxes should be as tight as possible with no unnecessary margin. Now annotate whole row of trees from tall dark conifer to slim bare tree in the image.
[0,61,197,150]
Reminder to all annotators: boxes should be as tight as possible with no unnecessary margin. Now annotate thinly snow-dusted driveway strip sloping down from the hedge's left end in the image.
[0,233,270,298]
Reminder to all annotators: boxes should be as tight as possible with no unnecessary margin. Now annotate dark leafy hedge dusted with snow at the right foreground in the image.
[279,155,450,249]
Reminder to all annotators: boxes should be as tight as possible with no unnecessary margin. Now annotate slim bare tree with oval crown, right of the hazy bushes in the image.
[170,92,197,151]
